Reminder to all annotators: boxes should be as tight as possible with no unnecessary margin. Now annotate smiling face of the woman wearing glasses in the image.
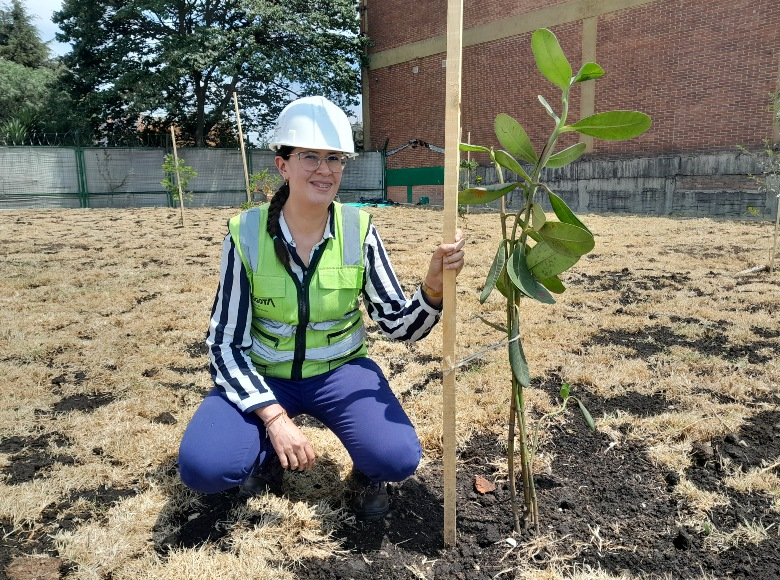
[274,147,343,207]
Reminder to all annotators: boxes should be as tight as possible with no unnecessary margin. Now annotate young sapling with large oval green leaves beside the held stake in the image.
[458,29,651,533]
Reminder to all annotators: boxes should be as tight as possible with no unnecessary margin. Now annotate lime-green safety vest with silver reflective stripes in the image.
[229,203,370,378]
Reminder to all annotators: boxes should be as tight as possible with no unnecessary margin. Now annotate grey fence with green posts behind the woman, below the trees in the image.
[0,146,385,209]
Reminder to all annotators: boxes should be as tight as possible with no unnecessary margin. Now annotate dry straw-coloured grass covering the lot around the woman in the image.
[0,208,780,580]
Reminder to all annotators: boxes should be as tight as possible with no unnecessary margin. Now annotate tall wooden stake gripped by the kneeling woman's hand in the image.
[442,0,463,546]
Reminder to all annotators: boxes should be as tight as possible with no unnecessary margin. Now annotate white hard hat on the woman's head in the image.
[268,97,355,155]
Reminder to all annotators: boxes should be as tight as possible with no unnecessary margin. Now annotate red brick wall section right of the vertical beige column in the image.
[596,0,780,153]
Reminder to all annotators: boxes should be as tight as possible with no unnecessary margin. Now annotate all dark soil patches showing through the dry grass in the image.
[0,212,780,580]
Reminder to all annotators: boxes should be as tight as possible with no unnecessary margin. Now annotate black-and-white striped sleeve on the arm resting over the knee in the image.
[206,234,276,413]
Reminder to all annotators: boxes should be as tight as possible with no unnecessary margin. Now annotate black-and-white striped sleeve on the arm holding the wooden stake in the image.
[363,224,441,342]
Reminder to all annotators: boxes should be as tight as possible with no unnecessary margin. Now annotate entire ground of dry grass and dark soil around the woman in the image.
[0,208,780,579]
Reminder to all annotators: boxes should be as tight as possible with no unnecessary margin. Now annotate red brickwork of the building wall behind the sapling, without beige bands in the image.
[368,0,780,167]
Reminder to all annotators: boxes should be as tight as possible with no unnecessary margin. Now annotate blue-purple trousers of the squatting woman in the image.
[179,358,422,493]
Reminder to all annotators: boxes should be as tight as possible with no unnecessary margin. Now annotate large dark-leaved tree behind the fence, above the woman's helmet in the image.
[53,0,363,146]
